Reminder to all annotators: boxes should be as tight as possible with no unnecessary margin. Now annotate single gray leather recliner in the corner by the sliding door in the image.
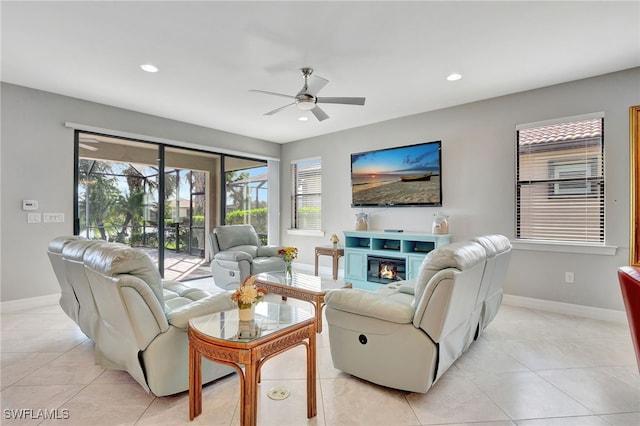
[209,225,285,290]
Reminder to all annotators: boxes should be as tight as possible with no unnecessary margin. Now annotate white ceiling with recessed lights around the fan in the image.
[1,0,640,143]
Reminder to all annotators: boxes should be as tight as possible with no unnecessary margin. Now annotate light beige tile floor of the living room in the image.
[0,280,640,426]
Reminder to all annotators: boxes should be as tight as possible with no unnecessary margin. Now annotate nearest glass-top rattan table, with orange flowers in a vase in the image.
[187,302,317,426]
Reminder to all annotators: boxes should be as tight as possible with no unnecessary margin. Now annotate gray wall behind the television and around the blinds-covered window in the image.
[281,68,640,310]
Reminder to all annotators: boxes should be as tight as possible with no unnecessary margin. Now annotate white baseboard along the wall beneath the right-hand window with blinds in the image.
[502,294,627,324]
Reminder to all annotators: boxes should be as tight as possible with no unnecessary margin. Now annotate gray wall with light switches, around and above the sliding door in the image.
[0,83,281,302]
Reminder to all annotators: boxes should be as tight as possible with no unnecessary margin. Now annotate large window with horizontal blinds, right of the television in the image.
[516,117,605,244]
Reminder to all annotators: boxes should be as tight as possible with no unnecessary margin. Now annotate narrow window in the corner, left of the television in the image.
[291,158,322,230]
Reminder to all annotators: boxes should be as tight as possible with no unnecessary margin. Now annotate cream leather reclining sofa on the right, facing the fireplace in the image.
[325,237,506,393]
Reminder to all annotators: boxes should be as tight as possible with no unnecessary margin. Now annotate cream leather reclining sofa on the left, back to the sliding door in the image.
[47,238,237,396]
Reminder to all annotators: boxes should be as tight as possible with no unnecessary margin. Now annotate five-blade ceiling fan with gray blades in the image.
[249,68,365,121]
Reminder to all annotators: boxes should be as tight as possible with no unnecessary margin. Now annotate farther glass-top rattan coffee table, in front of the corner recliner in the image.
[256,272,351,333]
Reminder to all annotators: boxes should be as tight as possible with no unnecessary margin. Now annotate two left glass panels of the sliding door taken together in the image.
[75,132,221,280]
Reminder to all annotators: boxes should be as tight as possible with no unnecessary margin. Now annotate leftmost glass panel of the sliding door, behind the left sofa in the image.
[75,134,159,259]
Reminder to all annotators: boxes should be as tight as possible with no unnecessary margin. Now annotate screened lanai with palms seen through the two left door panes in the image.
[78,159,209,280]
